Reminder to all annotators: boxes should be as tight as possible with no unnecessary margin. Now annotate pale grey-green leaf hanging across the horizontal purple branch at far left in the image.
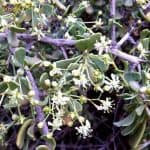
[7,31,19,47]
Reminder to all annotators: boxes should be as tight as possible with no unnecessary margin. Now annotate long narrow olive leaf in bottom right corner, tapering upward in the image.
[129,120,147,149]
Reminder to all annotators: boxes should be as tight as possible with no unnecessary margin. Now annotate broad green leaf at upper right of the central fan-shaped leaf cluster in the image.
[89,54,108,72]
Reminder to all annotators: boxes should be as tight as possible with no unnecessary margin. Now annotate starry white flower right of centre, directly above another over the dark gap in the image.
[104,74,123,91]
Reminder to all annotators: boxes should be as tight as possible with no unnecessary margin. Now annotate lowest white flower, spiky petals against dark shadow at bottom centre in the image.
[75,120,93,139]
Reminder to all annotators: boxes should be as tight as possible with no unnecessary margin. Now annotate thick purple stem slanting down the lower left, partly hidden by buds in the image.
[26,70,49,135]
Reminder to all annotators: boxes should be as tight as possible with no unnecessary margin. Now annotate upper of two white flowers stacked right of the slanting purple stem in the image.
[52,91,70,105]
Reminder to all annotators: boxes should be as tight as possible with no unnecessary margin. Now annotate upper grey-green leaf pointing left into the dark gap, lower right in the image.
[114,112,136,127]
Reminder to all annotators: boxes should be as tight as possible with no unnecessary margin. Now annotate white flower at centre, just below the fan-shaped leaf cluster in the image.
[73,74,88,88]
